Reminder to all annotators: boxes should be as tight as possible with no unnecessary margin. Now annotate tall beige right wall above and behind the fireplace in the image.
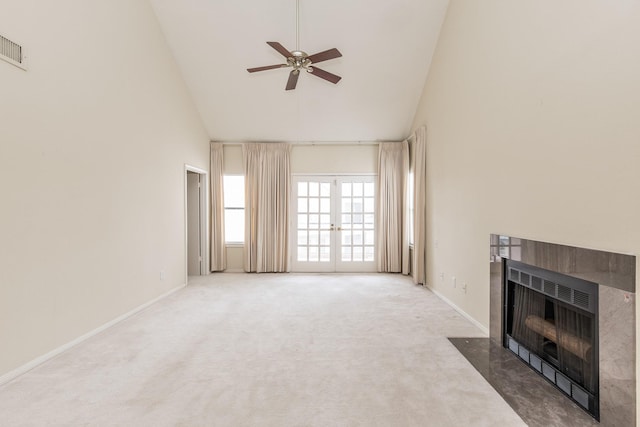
[414,0,640,422]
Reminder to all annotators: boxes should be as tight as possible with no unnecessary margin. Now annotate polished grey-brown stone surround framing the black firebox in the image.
[490,235,636,426]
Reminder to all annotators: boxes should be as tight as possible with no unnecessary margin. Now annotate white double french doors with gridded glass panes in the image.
[291,176,376,272]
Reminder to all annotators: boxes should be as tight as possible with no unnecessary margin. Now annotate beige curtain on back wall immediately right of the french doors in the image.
[376,141,409,274]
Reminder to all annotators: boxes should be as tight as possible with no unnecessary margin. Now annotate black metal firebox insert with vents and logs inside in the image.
[502,259,600,420]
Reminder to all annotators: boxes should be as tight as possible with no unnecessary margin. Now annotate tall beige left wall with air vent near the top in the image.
[0,0,208,375]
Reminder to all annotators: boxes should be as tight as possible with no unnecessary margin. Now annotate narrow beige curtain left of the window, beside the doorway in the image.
[209,142,227,271]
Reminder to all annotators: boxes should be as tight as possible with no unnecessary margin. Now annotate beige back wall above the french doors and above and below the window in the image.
[224,143,378,271]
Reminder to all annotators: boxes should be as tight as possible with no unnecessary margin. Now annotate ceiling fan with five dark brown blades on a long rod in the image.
[247,0,342,90]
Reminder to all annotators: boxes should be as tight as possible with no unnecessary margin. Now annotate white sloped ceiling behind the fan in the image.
[151,0,448,142]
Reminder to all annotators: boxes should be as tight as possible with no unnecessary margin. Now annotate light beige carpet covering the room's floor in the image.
[0,274,524,426]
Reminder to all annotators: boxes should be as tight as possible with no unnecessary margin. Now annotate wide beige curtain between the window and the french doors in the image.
[242,143,291,273]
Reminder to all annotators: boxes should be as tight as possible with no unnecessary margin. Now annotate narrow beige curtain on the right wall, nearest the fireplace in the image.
[411,126,427,285]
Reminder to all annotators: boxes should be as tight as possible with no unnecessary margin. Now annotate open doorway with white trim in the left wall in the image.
[185,166,208,282]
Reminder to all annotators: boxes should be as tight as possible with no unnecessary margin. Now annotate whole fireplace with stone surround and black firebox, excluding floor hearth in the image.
[489,234,636,426]
